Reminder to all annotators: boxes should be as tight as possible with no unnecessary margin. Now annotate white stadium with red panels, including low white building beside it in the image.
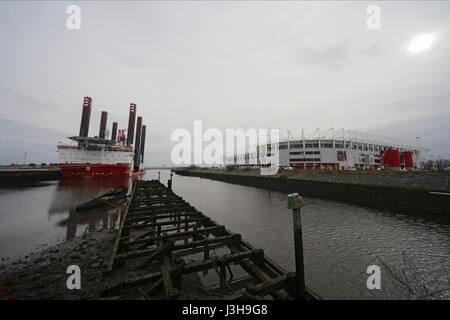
[226,129,422,170]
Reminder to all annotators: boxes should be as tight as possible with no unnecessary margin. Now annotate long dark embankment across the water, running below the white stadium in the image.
[174,169,450,215]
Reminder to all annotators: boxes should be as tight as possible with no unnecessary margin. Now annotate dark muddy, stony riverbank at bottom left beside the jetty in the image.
[0,229,117,300]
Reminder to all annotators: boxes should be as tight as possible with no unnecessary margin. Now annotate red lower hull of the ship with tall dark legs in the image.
[59,163,131,177]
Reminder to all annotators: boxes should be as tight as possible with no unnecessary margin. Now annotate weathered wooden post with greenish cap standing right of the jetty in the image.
[287,193,305,300]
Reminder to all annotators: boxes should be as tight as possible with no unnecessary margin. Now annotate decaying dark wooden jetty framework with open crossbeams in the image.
[100,180,318,299]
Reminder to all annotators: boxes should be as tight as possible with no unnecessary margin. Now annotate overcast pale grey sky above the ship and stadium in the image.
[0,1,450,165]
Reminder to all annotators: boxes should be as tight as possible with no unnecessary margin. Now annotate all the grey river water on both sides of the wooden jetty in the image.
[0,171,450,299]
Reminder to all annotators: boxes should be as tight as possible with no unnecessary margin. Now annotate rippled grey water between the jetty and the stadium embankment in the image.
[165,171,450,299]
